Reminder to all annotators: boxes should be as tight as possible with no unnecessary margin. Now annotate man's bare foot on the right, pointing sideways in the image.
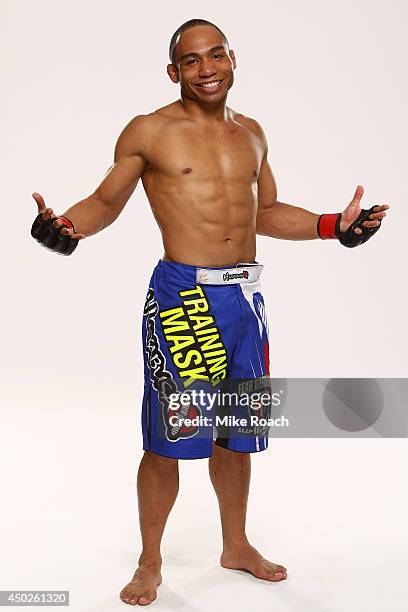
[220,544,287,582]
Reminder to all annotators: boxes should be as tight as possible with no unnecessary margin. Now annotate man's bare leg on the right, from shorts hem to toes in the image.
[208,444,286,582]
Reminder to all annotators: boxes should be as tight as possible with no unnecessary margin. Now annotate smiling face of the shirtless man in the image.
[167,26,236,104]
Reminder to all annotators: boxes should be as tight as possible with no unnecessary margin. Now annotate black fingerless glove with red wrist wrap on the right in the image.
[317,206,381,248]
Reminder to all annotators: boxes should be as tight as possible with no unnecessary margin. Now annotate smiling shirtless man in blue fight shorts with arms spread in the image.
[32,20,389,605]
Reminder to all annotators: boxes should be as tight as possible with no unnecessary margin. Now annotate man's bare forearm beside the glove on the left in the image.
[62,193,117,236]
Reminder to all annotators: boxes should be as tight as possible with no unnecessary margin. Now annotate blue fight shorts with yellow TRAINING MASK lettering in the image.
[142,260,270,459]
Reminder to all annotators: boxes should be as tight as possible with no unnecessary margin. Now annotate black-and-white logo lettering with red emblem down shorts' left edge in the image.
[143,288,201,442]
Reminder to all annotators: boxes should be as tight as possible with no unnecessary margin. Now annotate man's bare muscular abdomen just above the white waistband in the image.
[143,176,257,267]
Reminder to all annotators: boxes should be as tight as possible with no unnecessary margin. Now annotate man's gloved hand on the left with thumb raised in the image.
[31,193,85,255]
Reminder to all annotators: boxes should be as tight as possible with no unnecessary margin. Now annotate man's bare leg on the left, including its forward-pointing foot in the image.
[120,451,179,606]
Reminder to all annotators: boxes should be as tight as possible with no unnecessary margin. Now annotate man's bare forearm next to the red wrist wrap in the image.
[256,202,320,240]
